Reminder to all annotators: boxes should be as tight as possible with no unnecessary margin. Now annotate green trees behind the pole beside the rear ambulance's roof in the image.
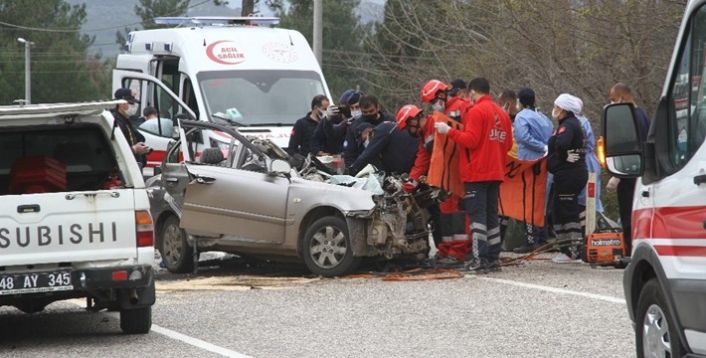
[267,0,367,99]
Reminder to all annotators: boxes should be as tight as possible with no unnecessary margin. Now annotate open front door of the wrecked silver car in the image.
[181,125,290,244]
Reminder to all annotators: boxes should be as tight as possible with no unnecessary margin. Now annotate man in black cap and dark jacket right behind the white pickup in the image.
[110,88,152,168]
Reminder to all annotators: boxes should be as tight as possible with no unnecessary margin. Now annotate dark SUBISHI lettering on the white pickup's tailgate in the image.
[0,221,118,250]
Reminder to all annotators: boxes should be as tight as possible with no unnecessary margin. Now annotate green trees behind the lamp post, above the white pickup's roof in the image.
[0,0,110,104]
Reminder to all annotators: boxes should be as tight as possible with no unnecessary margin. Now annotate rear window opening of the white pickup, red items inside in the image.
[0,124,118,195]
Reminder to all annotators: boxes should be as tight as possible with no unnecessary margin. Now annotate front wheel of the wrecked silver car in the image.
[302,216,360,277]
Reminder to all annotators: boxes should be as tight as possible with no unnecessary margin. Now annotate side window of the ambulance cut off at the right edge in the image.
[669,7,706,168]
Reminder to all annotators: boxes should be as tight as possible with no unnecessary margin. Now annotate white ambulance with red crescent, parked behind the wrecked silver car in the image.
[113,17,331,167]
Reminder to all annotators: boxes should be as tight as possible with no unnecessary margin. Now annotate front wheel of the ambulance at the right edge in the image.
[635,278,684,358]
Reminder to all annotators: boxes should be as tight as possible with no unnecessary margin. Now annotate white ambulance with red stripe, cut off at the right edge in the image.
[603,0,706,357]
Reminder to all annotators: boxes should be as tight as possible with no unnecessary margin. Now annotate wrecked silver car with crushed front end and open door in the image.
[147,121,429,276]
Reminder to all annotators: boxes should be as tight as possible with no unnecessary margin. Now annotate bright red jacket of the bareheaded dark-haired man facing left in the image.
[448,96,512,182]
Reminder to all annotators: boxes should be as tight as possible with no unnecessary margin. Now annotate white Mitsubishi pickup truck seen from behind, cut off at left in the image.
[0,101,155,333]
